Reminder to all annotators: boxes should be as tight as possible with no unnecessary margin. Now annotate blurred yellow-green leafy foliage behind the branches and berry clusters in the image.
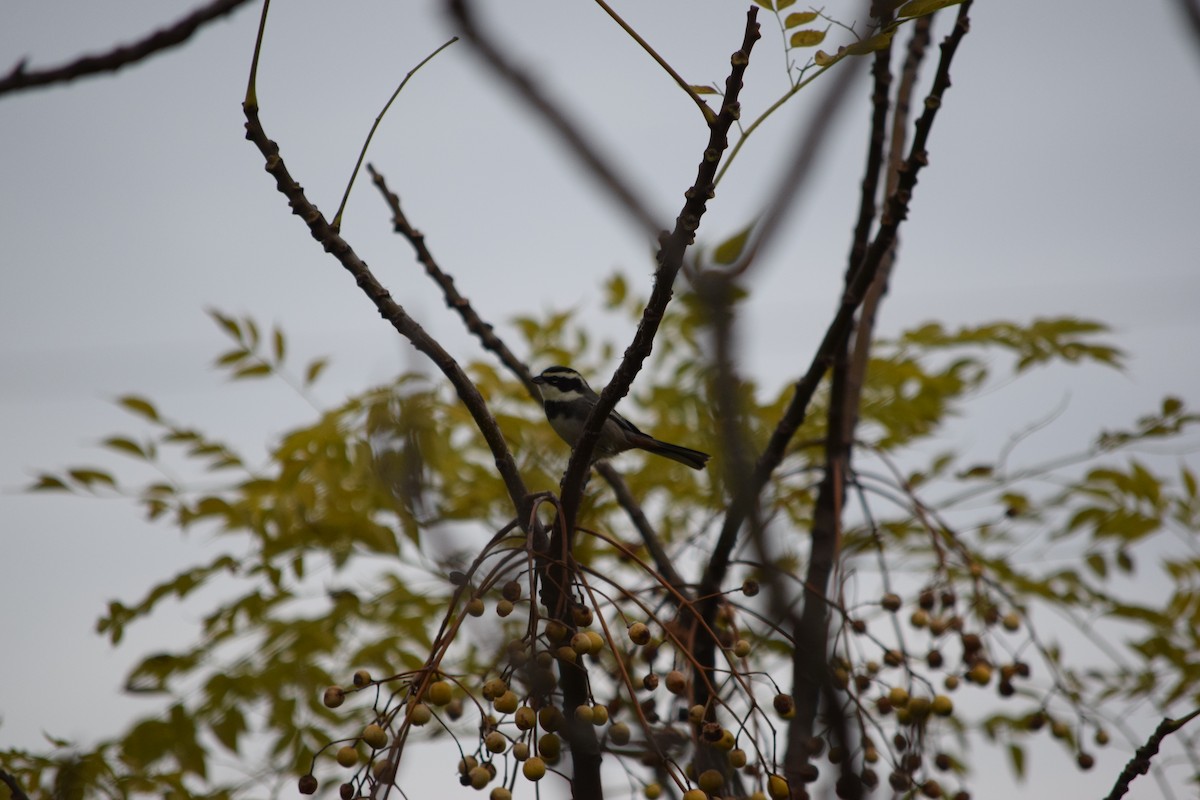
[5,296,1200,798]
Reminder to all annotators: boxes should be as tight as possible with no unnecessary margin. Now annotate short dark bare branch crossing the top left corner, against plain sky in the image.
[0,0,247,95]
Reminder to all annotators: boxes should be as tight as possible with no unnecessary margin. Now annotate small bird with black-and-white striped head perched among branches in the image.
[533,367,708,469]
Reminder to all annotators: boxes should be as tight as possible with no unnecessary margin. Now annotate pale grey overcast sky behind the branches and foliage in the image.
[0,0,1200,799]
